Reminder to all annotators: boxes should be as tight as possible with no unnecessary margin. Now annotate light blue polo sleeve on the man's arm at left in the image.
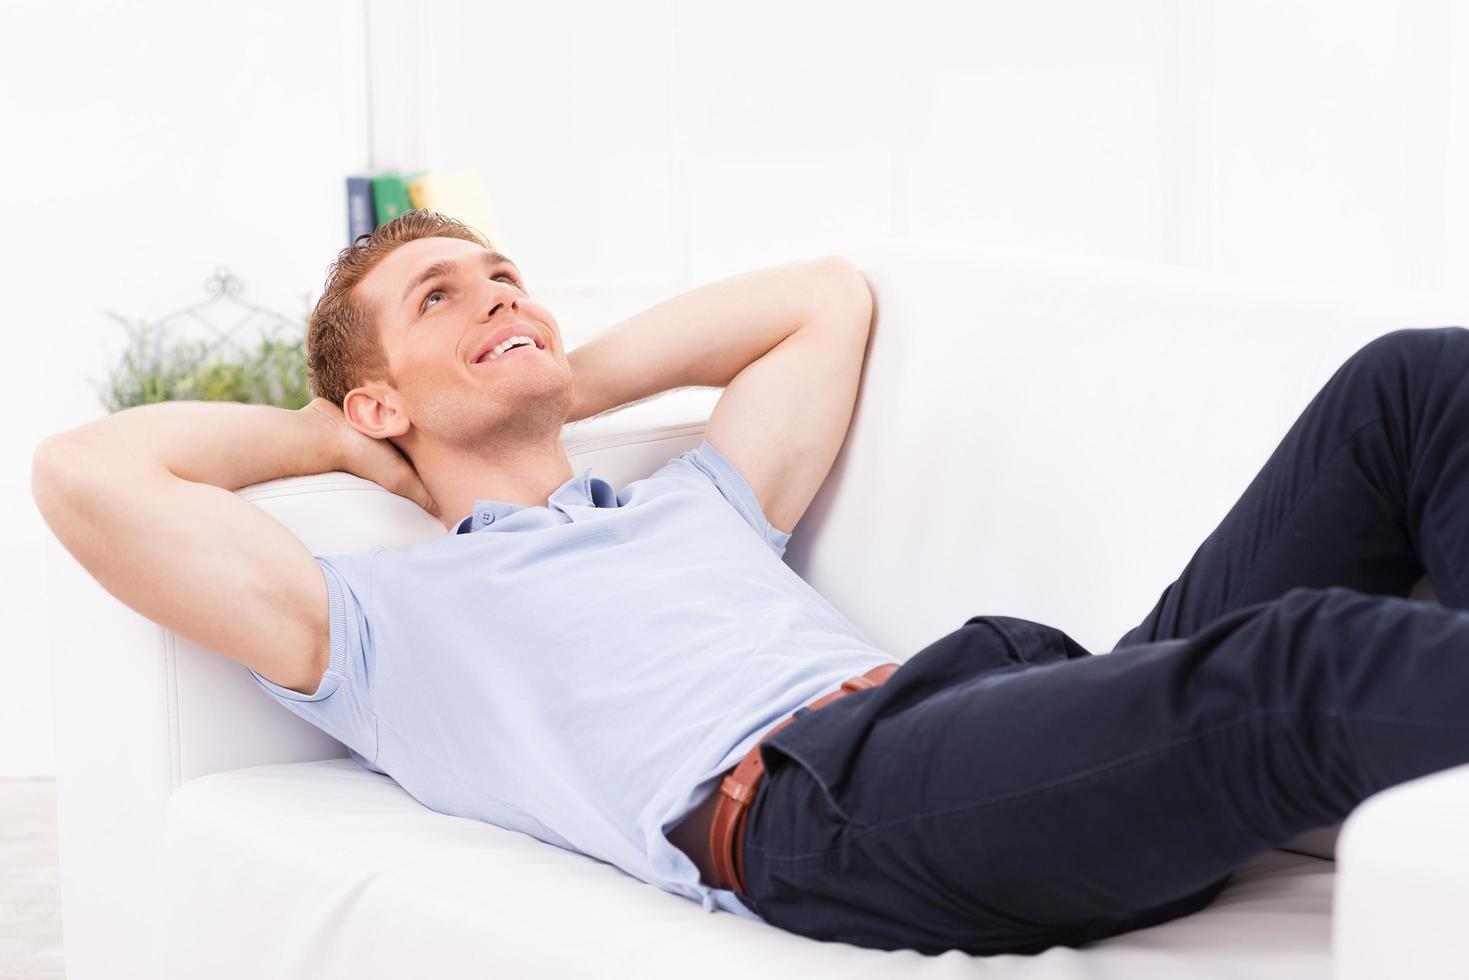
[247,548,382,771]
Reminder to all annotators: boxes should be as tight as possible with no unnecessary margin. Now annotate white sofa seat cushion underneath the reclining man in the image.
[160,758,1334,980]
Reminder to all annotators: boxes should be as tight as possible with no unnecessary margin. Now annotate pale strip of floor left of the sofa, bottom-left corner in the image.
[0,779,66,980]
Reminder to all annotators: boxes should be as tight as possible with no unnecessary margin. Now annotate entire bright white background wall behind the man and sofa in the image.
[0,0,1469,776]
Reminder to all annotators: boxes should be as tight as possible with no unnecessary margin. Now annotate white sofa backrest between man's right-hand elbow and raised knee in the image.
[786,241,1469,660]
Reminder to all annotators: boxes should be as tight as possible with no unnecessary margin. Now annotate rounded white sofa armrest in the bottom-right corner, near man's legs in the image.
[1331,765,1469,980]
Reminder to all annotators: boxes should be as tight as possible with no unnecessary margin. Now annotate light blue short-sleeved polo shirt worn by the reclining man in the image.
[251,439,892,920]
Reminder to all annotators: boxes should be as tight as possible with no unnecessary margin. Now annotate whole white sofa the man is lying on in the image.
[48,241,1469,980]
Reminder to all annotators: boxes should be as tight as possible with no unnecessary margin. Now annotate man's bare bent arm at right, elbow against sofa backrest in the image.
[569,256,873,530]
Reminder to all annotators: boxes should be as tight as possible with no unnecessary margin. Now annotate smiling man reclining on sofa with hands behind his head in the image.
[32,212,1469,954]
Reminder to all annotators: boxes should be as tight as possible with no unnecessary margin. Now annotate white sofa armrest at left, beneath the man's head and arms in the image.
[54,388,718,980]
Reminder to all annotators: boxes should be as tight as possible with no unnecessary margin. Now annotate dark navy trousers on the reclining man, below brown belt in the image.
[745,326,1469,954]
